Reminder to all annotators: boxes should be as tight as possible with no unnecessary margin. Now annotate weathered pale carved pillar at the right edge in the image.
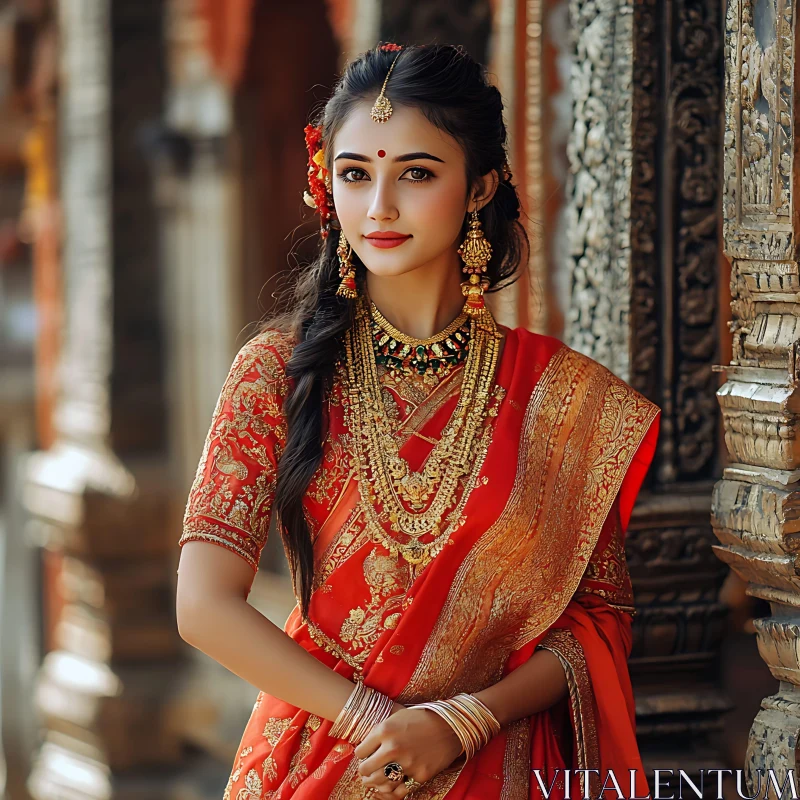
[713,0,800,790]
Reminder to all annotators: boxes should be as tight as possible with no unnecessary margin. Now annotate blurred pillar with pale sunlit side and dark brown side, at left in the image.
[25,0,188,800]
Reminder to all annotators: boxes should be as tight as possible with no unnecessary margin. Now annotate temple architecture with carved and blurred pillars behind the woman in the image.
[0,0,788,800]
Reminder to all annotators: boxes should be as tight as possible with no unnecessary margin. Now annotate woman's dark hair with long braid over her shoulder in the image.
[265,44,528,619]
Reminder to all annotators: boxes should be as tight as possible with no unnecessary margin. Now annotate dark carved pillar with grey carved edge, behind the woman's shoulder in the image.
[565,0,730,775]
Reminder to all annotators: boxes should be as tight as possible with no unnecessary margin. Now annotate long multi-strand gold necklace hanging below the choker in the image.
[345,298,501,565]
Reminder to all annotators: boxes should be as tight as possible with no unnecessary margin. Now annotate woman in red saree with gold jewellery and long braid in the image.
[177,45,659,800]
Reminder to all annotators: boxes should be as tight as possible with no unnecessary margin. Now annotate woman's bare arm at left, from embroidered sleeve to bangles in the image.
[176,541,382,720]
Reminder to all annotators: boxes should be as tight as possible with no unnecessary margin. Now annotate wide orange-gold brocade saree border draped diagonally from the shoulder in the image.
[398,346,658,703]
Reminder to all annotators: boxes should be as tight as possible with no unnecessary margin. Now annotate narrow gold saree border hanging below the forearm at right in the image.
[536,628,600,797]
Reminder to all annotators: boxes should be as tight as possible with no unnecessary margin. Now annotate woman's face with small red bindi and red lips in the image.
[332,101,467,275]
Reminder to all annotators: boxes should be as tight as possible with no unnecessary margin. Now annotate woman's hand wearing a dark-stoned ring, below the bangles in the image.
[355,703,462,797]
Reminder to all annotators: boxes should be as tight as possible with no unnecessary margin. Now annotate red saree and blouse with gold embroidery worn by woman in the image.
[180,328,659,800]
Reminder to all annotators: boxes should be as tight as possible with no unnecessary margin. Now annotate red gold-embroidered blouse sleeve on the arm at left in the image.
[179,332,288,570]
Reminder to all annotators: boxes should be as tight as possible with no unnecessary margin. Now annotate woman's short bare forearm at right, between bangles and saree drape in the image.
[473,650,568,726]
